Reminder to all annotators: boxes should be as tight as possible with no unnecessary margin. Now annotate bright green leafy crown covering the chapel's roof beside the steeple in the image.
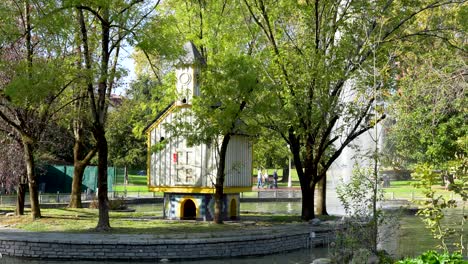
[177,54,258,144]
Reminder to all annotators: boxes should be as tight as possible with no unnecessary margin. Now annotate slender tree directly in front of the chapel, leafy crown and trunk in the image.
[192,54,258,224]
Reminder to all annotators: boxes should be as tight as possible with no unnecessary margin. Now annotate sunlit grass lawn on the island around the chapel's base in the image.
[0,207,306,234]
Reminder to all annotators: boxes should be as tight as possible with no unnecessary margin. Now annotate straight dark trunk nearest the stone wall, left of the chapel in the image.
[93,124,111,231]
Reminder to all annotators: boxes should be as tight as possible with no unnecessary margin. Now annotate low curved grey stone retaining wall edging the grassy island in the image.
[0,229,332,260]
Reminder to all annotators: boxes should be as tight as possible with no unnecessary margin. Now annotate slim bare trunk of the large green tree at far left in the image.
[23,140,41,219]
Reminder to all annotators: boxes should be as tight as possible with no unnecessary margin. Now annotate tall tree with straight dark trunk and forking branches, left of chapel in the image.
[69,0,159,230]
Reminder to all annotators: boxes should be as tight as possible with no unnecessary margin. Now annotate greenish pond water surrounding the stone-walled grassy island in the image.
[0,202,468,264]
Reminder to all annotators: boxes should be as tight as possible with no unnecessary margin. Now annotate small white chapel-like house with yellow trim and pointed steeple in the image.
[146,42,252,221]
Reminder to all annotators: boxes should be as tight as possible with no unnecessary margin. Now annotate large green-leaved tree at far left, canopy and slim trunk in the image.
[0,0,73,218]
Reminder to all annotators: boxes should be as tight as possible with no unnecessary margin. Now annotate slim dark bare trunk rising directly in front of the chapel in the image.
[213,134,231,224]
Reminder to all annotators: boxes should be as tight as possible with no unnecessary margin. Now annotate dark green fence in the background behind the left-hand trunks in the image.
[38,165,119,193]
